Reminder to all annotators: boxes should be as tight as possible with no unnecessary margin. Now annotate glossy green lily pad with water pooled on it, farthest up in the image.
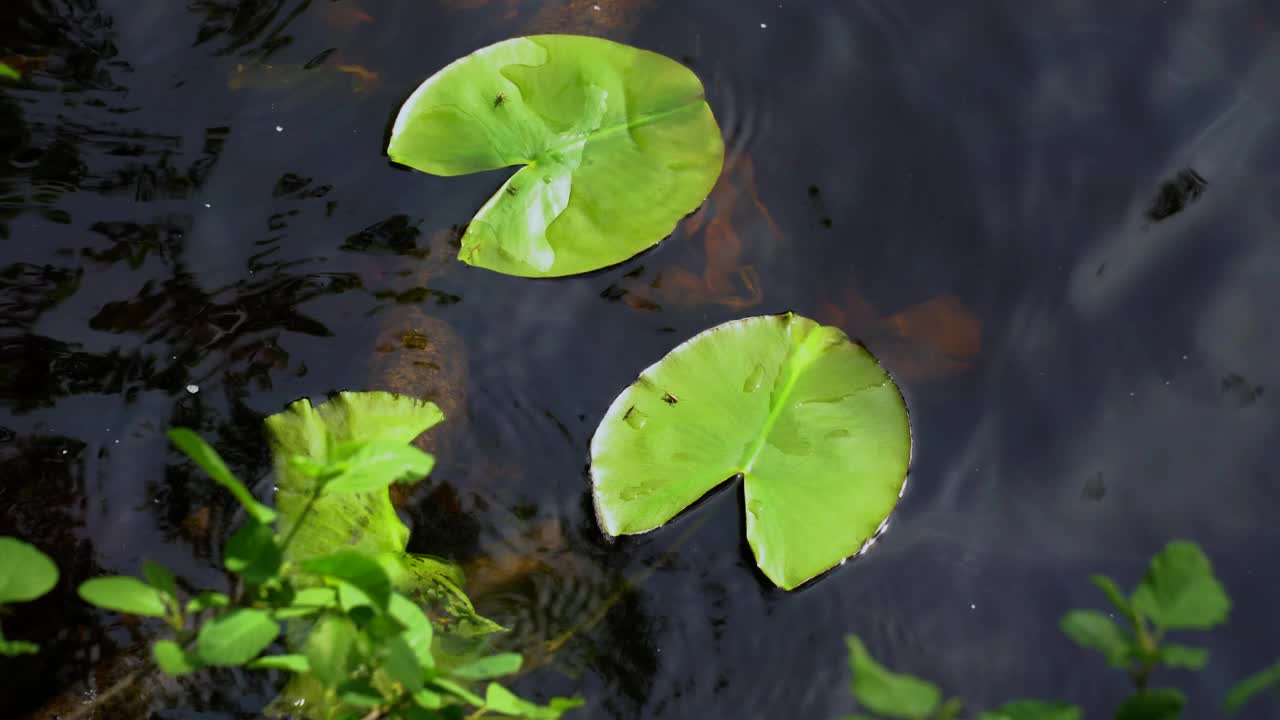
[387,35,724,277]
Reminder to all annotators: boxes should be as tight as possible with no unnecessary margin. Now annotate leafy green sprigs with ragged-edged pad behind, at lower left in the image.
[72,393,581,720]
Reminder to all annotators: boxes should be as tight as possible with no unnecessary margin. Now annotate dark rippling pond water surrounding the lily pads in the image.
[0,0,1280,719]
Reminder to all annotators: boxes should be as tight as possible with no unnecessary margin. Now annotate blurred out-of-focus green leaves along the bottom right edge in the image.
[847,541,1280,720]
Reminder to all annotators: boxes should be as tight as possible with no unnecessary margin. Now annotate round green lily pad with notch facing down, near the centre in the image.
[591,313,911,589]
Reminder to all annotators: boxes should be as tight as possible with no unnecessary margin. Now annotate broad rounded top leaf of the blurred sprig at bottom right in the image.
[1133,541,1231,630]
